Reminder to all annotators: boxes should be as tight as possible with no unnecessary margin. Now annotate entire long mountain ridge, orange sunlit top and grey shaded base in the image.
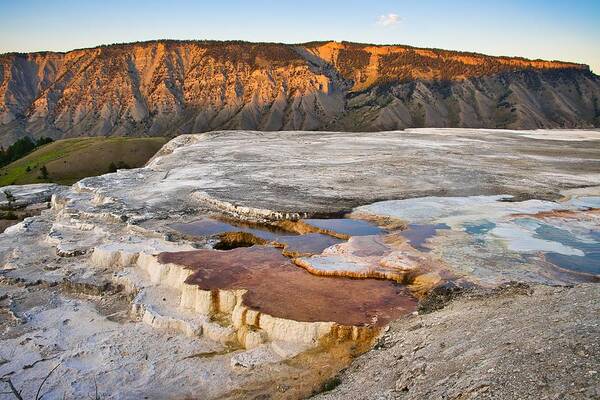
[0,41,600,144]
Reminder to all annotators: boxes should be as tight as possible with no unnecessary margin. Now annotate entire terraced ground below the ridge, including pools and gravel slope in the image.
[0,129,600,399]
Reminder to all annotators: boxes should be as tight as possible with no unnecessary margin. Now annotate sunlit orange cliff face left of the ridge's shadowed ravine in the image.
[0,42,338,128]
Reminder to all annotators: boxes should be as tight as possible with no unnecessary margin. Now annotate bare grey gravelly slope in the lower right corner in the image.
[316,284,600,399]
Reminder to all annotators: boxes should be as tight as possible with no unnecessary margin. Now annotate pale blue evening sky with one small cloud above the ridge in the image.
[0,0,600,74]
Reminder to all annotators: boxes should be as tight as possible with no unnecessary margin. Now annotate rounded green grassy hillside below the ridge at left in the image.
[0,137,169,186]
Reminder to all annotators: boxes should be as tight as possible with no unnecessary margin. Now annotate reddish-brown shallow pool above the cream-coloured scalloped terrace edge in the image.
[158,246,417,326]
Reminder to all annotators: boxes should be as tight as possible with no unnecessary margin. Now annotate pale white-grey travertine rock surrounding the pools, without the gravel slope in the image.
[0,130,600,399]
